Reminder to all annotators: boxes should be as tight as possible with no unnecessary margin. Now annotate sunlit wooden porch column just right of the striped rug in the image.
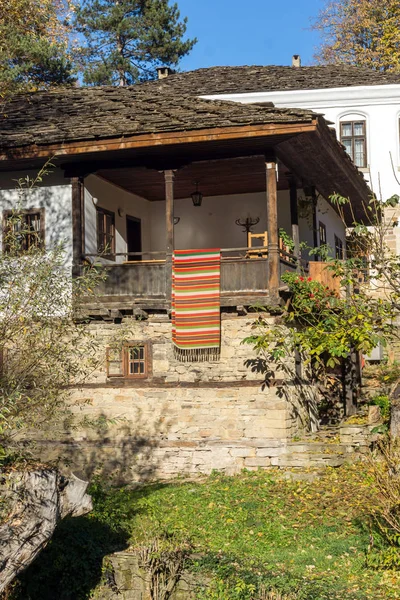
[265,157,280,304]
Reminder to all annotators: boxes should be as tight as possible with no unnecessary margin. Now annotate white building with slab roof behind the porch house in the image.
[150,61,400,199]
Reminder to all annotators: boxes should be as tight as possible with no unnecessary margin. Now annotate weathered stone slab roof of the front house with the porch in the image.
[0,85,315,149]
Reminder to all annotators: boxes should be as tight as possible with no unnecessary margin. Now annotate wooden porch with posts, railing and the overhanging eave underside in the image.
[65,112,368,314]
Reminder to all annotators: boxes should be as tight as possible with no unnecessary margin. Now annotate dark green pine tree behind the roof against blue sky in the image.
[75,0,197,85]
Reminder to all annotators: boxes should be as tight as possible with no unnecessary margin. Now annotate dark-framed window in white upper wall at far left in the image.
[3,208,45,252]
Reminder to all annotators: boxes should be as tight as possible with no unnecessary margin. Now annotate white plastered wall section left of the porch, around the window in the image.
[0,171,72,264]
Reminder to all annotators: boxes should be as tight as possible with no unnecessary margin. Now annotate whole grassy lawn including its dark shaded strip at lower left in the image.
[12,464,400,600]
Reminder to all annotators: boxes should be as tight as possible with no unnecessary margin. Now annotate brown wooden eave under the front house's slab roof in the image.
[0,115,371,225]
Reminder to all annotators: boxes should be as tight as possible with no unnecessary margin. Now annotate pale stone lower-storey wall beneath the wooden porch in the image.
[32,313,316,481]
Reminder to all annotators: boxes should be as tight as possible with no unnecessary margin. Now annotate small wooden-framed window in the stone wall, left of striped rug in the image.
[107,342,151,379]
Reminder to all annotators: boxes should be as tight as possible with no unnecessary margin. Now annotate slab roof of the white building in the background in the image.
[142,65,400,96]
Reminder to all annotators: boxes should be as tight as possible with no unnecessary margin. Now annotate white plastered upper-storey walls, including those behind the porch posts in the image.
[0,173,344,264]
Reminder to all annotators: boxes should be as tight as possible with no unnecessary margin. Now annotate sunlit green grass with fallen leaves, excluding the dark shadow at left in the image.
[86,466,400,600]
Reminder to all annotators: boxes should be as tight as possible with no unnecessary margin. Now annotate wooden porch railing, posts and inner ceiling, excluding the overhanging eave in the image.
[78,153,300,310]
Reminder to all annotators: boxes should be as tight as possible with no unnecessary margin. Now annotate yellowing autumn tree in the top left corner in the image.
[0,0,74,95]
